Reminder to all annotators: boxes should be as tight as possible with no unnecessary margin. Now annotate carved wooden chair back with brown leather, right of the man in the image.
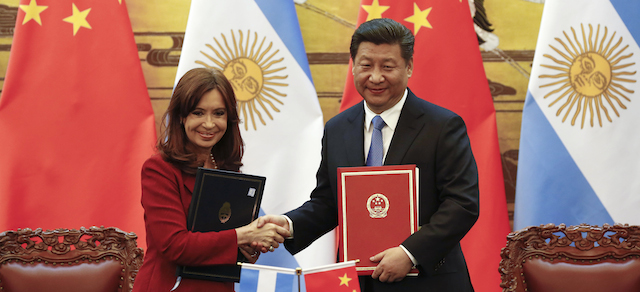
[499,224,640,292]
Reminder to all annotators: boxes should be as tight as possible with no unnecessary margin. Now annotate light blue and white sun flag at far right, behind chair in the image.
[514,0,640,229]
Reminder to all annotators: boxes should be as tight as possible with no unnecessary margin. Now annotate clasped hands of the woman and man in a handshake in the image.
[236,220,290,248]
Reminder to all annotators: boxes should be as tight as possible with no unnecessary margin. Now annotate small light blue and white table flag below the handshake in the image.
[237,264,300,292]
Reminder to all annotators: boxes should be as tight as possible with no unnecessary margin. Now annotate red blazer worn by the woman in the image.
[133,154,238,292]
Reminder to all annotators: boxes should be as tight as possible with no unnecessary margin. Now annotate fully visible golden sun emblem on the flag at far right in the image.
[539,24,636,128]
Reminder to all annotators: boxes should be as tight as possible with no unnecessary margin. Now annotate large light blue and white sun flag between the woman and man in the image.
[176,0,335,268]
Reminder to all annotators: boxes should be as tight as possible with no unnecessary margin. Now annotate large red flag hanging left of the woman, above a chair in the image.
[0,0,156,247]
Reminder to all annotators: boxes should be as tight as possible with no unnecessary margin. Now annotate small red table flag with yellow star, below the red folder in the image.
[304,261,360,292]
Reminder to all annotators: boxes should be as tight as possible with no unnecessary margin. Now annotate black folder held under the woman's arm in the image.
[176,167,266,282]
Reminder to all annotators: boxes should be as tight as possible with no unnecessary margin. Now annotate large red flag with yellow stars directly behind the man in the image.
[340,0,509,292]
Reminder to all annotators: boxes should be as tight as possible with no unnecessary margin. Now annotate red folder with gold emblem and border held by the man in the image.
[338,165,419,275]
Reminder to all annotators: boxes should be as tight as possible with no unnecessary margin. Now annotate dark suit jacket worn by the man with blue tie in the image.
[285,90,479,292]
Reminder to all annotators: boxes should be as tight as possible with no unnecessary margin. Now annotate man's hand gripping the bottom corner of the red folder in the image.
[371,247,413,283]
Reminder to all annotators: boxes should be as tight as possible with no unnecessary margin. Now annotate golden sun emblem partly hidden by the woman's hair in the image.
[196,30,288,130]
